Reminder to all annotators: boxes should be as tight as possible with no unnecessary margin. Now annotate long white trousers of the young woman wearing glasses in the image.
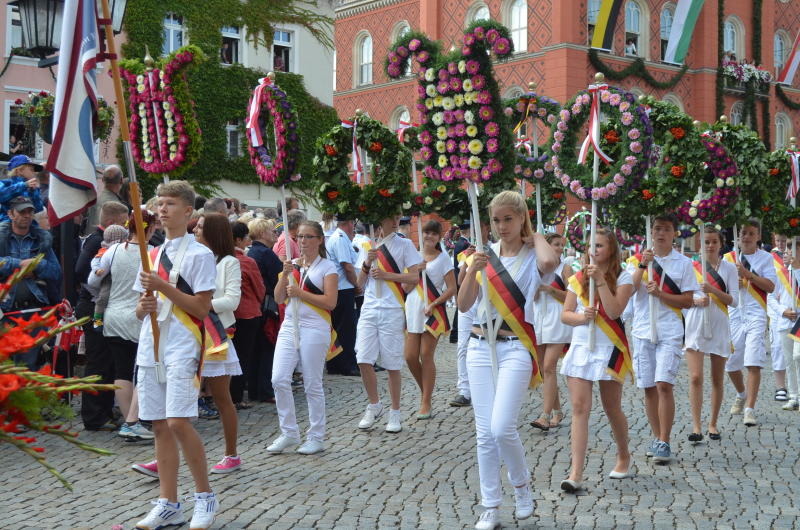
[272,326,331,442]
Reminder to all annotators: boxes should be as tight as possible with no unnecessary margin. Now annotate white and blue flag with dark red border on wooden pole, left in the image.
[45,0,100,225]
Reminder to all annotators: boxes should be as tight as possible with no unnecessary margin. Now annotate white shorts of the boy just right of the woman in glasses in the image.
[356,307,406,370]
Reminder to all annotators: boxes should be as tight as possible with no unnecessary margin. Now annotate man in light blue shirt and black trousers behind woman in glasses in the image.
[325,214,361,376]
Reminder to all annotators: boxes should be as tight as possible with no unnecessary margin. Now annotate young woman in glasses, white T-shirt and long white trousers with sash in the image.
[267,221,339,455]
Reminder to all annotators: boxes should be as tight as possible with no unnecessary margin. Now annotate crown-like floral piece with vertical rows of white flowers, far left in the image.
[121,45,205,178]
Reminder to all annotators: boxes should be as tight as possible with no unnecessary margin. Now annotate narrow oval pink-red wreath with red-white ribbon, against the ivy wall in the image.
[247,74,300,186]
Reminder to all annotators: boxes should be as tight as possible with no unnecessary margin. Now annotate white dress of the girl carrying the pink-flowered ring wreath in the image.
[561,270,633,381]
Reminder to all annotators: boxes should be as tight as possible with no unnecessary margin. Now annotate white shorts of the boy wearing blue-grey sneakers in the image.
[633,337,683,388]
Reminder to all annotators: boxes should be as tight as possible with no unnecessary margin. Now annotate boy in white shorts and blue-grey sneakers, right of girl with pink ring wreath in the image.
[628,214,700,464]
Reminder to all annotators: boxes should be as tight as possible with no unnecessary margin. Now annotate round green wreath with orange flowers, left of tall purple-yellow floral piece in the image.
[314,115,411,223]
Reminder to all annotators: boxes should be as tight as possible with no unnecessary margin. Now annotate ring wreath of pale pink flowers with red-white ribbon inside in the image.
[550,87,653,203]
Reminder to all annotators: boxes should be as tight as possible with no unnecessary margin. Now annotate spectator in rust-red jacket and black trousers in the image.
[231,221,266,409]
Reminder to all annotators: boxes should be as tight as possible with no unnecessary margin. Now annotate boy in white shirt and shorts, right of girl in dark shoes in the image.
[725,219,777,427]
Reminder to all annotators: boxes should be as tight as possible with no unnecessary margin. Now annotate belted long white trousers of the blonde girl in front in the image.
[467,338,533,508]
